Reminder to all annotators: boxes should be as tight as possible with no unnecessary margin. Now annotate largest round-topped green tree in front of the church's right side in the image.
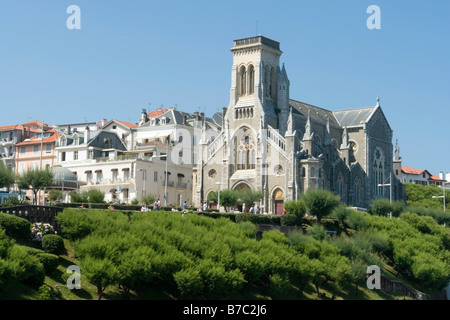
[302,189,340,223]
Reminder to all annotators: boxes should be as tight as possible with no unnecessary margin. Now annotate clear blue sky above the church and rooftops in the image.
[0,0,450,175]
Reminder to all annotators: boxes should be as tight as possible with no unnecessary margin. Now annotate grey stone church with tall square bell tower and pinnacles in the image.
[193,36,404,214]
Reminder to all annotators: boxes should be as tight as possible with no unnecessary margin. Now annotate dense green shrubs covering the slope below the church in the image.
[0,209,448,300]
